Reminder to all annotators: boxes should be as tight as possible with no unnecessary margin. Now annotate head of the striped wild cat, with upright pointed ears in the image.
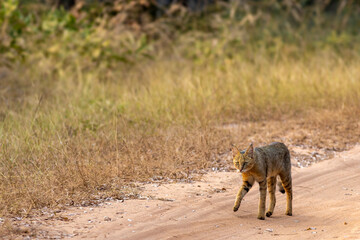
[232,143,255,173]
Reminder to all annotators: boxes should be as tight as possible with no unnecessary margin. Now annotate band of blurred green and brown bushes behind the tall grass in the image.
[0,0,360,66]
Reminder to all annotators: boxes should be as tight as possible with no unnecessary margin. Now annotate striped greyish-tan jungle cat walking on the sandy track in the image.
[233,142,292,220]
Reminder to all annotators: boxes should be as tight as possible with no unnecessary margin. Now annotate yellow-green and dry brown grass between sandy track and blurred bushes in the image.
[0,49,360,218]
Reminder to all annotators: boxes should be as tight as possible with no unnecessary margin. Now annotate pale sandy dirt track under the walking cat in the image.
[40,147,360,239]
